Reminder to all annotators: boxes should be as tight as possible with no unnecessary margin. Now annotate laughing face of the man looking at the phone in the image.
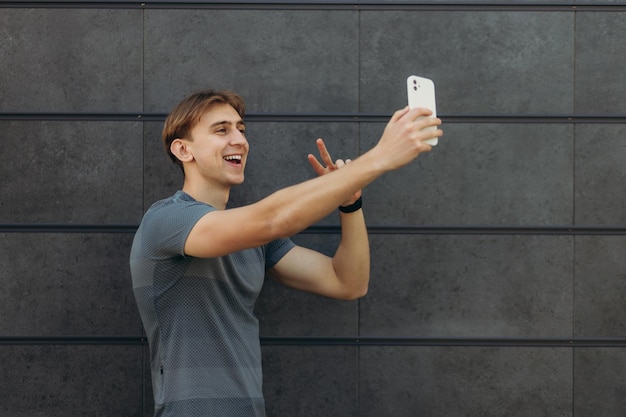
[188,104,249,186]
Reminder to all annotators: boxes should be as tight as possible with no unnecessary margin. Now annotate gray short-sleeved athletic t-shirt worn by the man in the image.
[130,191,294,417]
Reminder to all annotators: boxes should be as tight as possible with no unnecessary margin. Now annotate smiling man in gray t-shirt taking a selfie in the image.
[130,90,442,417]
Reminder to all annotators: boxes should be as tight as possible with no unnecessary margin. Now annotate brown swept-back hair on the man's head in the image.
[161,90,246,172]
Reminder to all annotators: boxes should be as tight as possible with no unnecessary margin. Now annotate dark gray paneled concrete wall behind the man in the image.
[0,0,626,417]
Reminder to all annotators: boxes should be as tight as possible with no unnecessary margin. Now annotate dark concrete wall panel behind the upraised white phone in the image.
[360,11,574,115]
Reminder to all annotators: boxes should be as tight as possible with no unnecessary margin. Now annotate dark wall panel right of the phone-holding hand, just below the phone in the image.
[361,121,574,226]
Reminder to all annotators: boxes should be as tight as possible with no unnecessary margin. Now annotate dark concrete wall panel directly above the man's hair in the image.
[145,10,359,113]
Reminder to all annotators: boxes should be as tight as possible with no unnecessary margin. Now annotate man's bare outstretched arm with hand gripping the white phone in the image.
[185,107,443,257]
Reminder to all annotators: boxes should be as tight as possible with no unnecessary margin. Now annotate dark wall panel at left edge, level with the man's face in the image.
[0,121,143,224]
